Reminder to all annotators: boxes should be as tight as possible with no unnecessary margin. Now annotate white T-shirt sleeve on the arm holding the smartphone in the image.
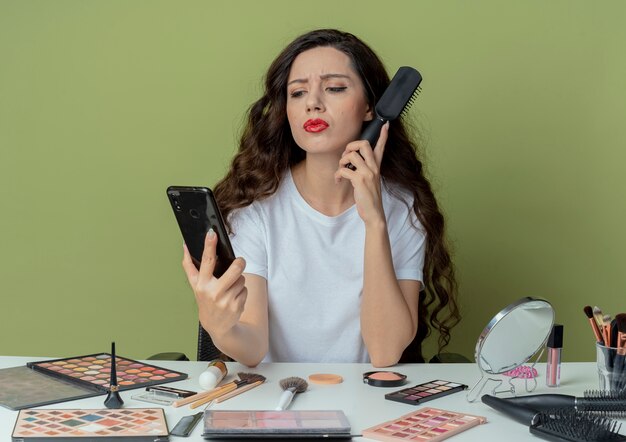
[229,203,267,279]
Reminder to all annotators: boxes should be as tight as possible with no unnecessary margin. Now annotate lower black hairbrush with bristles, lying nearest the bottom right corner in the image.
[481,394,626,442]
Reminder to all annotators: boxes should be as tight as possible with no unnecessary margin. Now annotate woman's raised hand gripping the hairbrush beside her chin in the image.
[335,122,389,224]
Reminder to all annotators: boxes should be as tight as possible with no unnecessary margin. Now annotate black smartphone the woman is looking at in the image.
[167,186,235,278]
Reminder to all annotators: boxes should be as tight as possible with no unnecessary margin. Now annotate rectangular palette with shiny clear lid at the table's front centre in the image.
[202,410,351,439]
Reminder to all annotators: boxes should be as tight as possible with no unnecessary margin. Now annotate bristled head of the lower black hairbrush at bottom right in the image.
[530,410,626,442]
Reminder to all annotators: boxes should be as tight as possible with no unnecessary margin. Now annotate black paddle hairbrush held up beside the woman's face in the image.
[346,66,422,170]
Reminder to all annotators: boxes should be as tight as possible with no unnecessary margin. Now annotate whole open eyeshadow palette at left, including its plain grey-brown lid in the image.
[0,353,187,410]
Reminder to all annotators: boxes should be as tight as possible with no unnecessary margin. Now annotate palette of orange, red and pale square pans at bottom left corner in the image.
[12,408,169,442]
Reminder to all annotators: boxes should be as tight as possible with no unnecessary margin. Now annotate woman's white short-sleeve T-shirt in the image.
[230,171,425,362]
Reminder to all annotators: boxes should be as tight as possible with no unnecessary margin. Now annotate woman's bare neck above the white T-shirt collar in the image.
[291,158,354,216]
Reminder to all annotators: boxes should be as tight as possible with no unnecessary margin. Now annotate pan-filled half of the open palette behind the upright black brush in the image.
[26,353,187,392]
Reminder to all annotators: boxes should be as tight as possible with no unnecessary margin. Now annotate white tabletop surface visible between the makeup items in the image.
[0,356,623,442]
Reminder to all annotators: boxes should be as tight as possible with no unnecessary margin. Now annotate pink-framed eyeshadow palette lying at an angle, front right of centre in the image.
[363,408,487,442]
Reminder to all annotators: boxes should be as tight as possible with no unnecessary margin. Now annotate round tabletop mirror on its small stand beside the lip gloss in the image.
[468,297,554,401]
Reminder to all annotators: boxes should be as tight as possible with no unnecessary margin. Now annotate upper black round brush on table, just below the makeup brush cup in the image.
[503,391,626,418]
